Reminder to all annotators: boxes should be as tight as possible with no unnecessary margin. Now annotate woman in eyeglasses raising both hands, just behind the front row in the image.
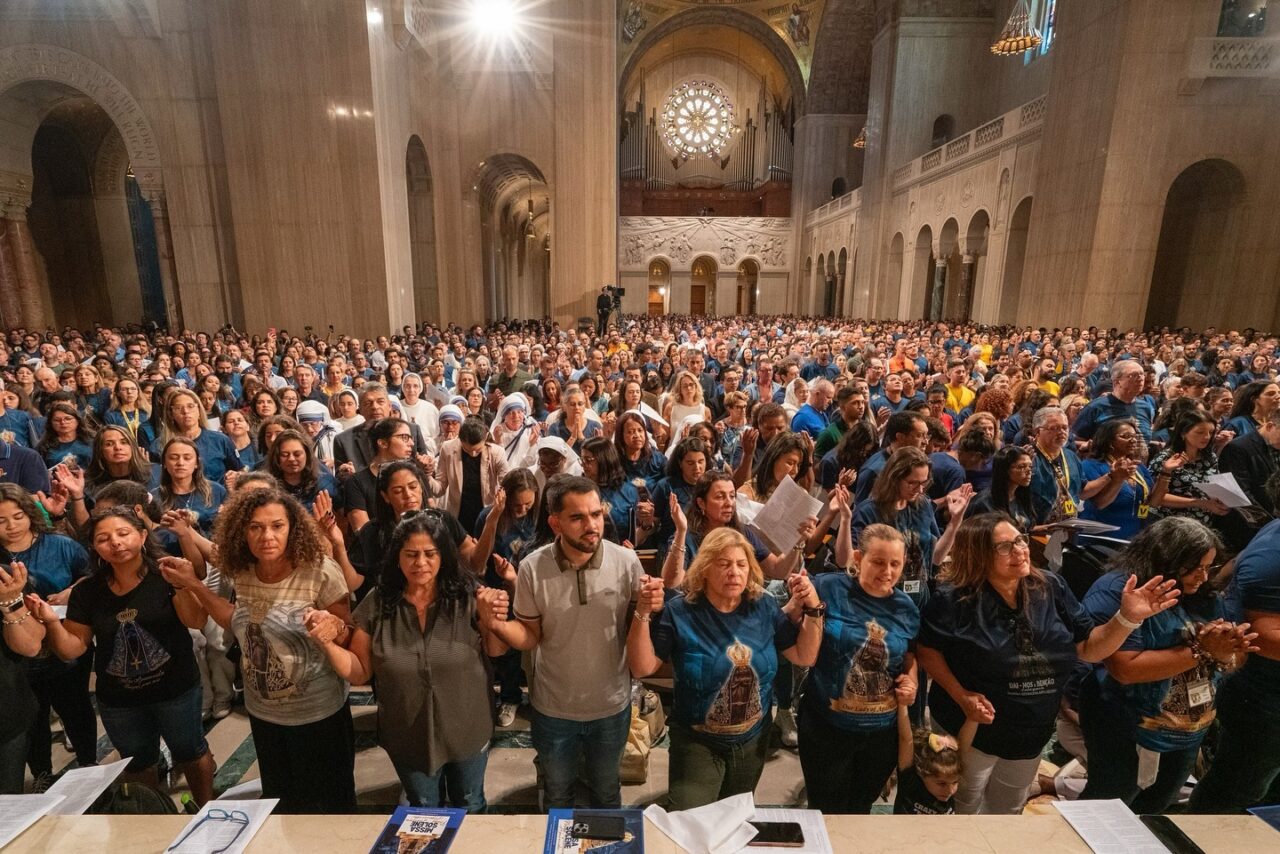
[836,448,973,604]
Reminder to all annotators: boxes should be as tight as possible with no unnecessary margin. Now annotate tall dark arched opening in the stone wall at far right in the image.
[1146,160,1244,329]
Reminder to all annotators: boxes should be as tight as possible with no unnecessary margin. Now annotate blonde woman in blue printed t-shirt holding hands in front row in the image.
[627,528,824,809]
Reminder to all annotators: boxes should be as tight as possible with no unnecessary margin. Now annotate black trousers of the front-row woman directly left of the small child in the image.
[796,694,897,816]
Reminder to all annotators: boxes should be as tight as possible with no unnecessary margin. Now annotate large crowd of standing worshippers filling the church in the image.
[0,306,1280,814]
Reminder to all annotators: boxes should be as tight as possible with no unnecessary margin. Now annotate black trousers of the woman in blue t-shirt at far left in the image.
[27,649,97,777]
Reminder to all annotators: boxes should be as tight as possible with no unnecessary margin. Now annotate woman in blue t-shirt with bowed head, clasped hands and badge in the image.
[1080,516,1257,813]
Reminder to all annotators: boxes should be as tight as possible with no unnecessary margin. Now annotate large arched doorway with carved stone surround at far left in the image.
[0,45,177,328]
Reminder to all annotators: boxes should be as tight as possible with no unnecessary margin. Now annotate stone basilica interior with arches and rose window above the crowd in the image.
[0,0,1280,335]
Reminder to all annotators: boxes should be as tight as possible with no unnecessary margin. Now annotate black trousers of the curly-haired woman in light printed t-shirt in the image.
[248,703,356,814]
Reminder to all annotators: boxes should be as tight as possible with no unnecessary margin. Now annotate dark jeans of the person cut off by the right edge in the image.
[1182,676,1280,813]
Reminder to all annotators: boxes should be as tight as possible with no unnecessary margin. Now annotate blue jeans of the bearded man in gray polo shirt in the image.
[531,704,631,809]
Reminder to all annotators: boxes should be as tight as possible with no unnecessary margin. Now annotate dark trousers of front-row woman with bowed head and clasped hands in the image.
[1080,680,1199,816]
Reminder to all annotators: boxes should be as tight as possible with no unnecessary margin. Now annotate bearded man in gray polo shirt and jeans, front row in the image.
[494,476,644,809]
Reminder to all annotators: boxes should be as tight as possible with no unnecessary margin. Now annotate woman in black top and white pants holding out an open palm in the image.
[921,512,1178,814]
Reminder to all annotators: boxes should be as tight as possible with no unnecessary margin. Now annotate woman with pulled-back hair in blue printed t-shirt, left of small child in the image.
[799,512,920,814]
